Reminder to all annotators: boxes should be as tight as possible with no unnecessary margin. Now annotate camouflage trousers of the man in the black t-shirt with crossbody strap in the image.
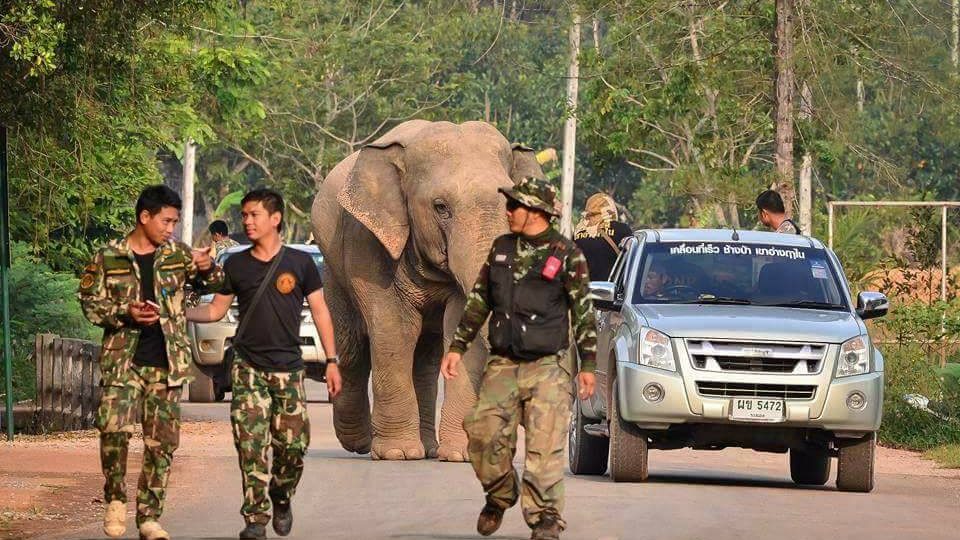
[230,356,310,523]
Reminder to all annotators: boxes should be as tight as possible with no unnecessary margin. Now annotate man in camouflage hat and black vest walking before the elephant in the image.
[441,178,597,540]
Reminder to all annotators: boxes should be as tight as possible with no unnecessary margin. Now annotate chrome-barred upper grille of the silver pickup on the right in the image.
[687,339,827,375]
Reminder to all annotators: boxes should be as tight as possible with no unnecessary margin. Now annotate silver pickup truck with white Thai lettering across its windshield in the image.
[569,229,888,492]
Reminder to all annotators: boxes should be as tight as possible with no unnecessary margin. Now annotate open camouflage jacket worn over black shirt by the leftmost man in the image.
[79,238,223,386]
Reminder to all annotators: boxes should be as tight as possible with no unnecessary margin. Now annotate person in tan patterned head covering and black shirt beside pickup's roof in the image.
[573,193,633,281]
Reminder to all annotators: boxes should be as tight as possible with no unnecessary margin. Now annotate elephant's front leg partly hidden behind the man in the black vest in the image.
[437,299,487,461]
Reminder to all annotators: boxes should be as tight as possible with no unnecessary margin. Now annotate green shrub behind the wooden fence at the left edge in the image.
[0,242,99,400]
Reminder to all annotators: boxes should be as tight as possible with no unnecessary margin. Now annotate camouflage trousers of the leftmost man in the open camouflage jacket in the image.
[96,366,182,526]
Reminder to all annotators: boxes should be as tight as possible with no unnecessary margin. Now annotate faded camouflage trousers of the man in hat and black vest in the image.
[463,355,573,527]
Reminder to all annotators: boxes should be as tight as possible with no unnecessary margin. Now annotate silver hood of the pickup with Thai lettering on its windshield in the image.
[634,304,863,343]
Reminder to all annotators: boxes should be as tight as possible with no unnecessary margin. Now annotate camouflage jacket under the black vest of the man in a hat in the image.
[450,228,597,372]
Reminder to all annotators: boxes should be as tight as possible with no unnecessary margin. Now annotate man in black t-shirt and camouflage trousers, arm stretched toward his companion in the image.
[187,189,341,539]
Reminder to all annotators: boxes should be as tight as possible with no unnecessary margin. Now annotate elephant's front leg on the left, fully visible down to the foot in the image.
[367,305,425,459]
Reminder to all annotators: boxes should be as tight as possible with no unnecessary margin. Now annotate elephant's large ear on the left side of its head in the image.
[337,143,410,260]
